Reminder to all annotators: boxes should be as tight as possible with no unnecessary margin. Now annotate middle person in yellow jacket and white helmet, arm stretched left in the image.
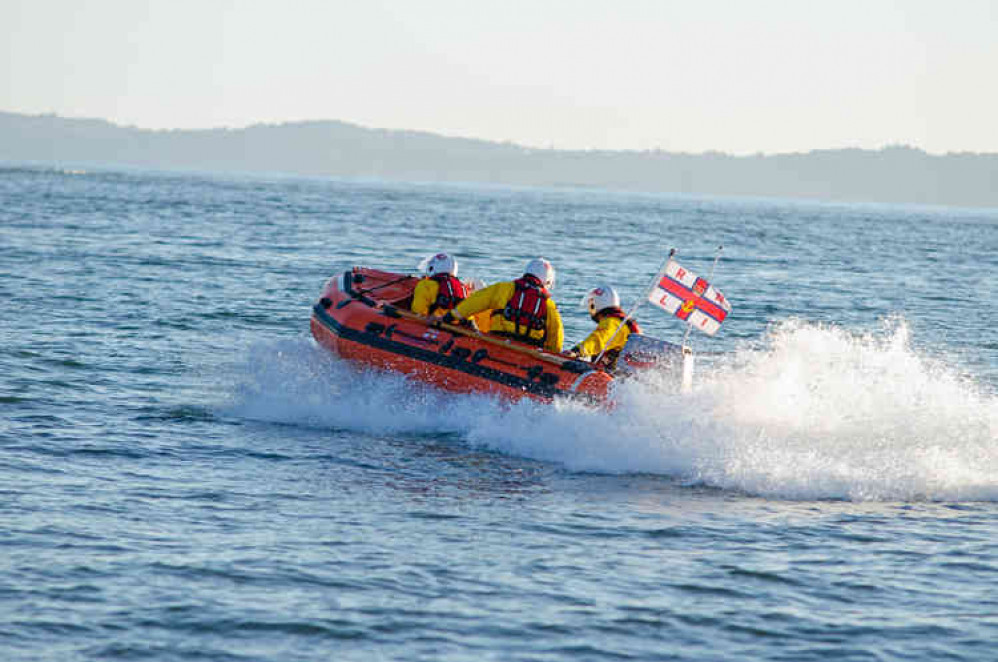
[443,258,565,352]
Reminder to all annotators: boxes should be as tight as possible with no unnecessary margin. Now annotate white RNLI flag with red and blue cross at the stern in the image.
[648,258,731,336]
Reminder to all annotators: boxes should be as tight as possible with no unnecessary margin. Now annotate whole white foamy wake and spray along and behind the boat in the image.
[225,320,998,501]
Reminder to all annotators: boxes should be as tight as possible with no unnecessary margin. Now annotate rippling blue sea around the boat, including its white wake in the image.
[0,164,998,662]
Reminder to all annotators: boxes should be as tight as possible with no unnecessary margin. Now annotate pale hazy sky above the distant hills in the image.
[0,0,998,154]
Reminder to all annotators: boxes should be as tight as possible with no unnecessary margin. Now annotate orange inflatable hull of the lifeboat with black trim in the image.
[311,267,613,402]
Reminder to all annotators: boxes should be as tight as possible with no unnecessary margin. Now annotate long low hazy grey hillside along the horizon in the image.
[0,112,998,207]
